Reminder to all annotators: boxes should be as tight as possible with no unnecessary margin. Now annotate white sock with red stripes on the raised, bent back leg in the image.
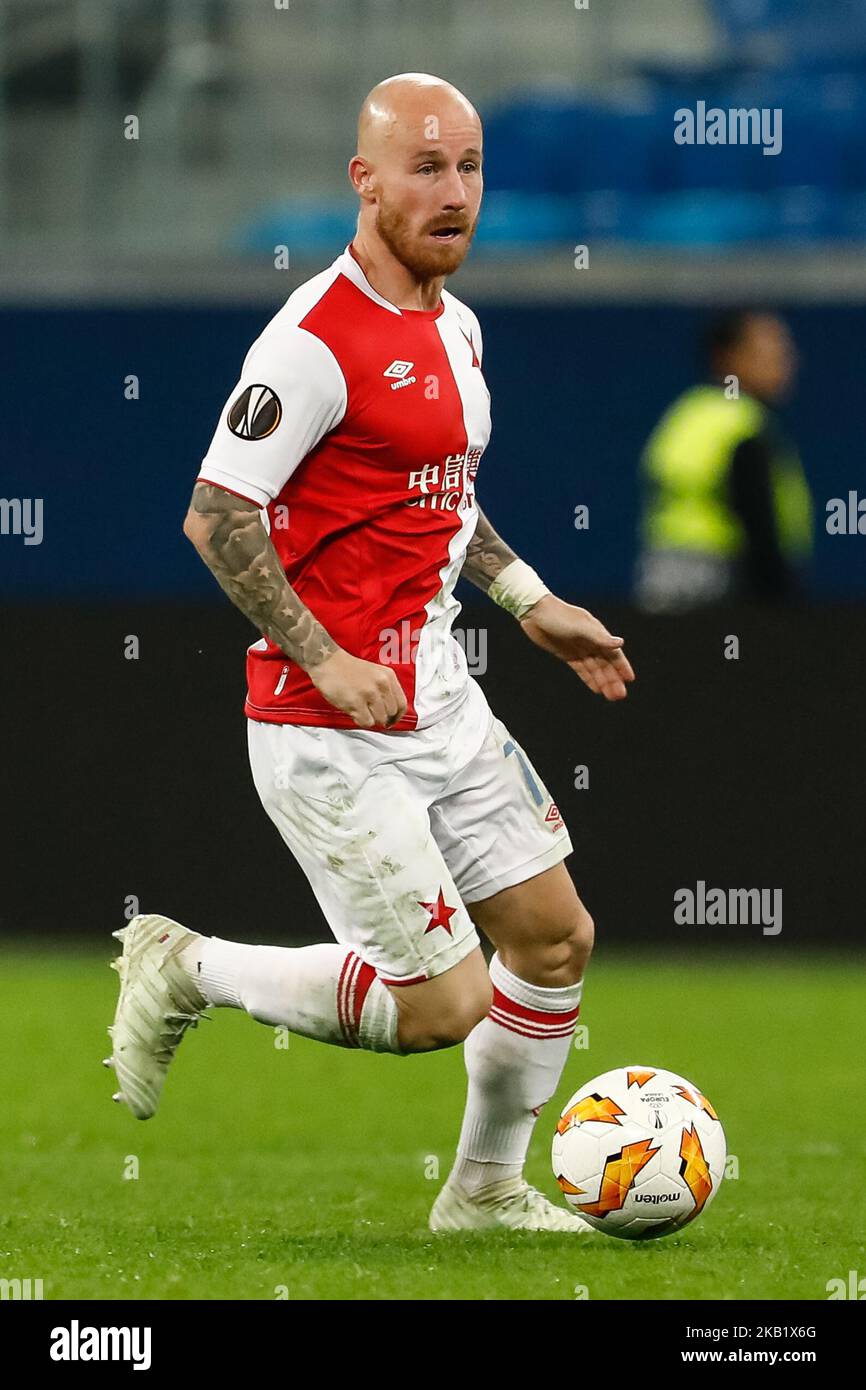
[178,937,402,1055]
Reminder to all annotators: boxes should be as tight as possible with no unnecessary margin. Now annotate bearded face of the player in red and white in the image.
[377,111,482,279]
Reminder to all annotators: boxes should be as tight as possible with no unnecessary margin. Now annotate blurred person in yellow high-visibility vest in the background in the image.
[635,309,813,613]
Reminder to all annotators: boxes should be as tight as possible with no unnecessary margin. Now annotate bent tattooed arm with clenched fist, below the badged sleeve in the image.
[183,482,406,728]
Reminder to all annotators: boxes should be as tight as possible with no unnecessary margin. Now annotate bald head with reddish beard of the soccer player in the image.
[349,72,482,279]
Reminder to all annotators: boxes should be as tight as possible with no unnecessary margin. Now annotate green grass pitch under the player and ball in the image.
[0,937,866,1300]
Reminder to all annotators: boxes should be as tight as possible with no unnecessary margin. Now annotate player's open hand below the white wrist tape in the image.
[520,594,634,699]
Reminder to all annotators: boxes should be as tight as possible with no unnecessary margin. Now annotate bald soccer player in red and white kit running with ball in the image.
[107,74,634,1234]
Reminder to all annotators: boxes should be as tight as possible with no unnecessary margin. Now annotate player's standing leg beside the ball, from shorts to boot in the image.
[422,700,594,1233]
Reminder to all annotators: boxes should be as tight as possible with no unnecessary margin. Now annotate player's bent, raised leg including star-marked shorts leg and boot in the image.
[108,724,491,1119]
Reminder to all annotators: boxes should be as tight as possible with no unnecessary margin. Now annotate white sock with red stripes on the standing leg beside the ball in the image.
[452,955,584,1193]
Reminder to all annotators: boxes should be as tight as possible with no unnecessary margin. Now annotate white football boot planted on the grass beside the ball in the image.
[430,1177,596,1236]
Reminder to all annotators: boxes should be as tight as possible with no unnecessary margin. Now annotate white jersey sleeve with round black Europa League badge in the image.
[197,325,346,507]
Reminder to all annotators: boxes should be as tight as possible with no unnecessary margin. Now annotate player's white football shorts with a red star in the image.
[247,677,573,984]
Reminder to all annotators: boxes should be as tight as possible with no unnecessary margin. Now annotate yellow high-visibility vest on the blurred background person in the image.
[641,386,813,559]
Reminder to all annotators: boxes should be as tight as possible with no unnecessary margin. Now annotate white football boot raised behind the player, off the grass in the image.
[103,915,207,1120]
